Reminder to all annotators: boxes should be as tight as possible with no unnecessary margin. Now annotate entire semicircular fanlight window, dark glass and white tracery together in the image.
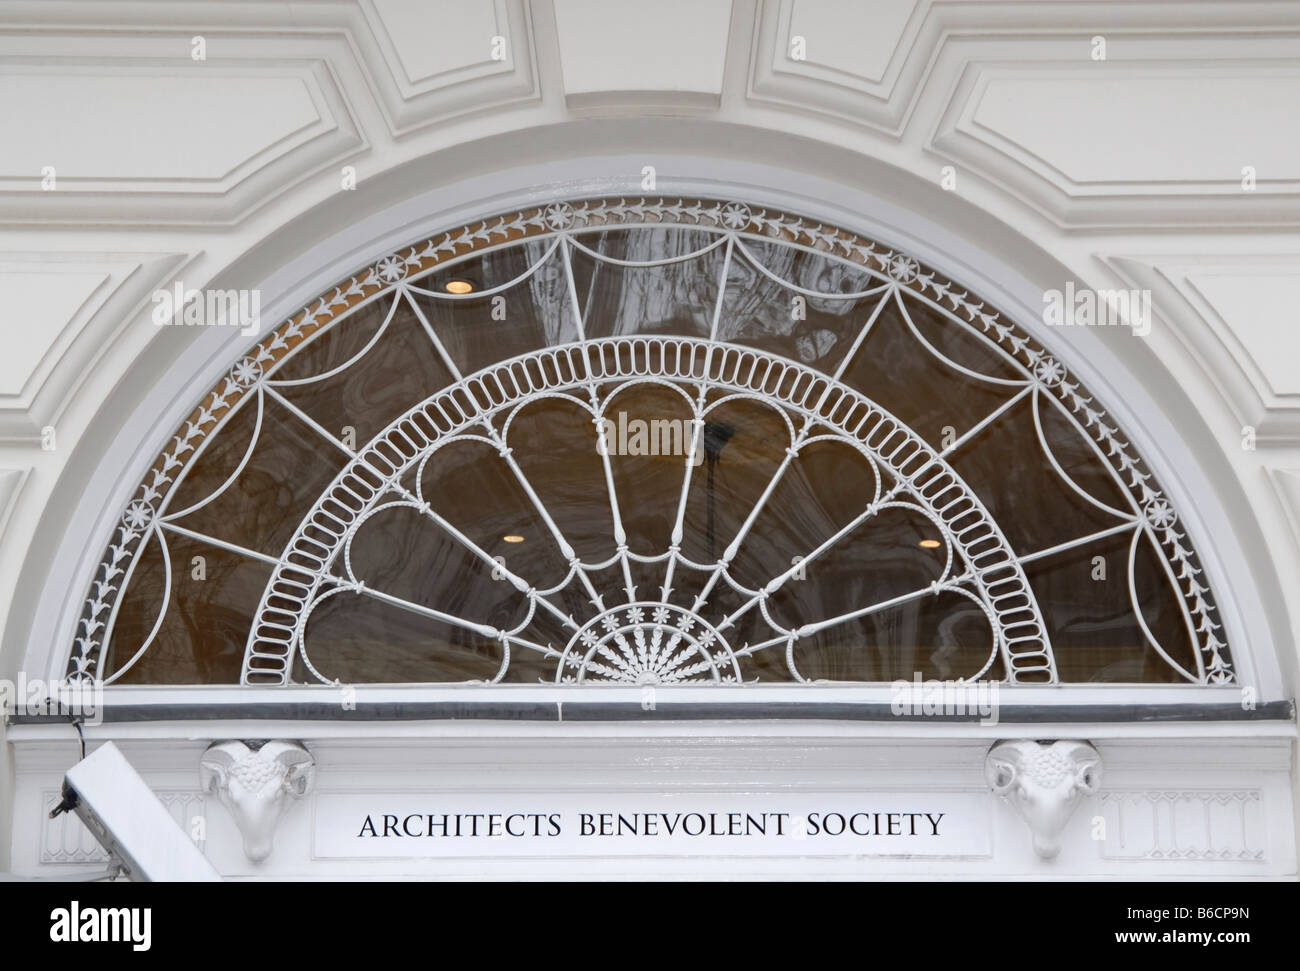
[69,200,1235,685]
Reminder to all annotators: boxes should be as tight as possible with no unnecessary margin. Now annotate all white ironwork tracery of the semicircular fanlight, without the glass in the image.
[69,200,1232,684]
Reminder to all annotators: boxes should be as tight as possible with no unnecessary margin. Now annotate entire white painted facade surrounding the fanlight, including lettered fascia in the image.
[0,0,1300,880]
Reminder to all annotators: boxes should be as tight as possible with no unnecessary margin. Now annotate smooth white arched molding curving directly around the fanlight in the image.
[7,144,1286,698]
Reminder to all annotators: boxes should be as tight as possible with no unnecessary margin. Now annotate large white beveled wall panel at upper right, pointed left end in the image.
[930,53,1300,227]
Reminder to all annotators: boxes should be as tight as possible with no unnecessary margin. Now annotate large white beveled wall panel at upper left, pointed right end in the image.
[0,42,369,227]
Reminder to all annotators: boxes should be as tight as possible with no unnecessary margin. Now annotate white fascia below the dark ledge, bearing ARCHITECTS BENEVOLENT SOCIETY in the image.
[7,723,1295,880]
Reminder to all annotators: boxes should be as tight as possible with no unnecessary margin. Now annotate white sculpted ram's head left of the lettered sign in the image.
[199,741,316,863]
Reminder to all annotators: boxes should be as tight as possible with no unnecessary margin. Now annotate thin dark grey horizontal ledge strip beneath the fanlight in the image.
[8,701,1295,725]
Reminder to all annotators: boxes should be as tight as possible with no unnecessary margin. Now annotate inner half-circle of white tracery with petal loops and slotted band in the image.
[243,338,1056,684]
